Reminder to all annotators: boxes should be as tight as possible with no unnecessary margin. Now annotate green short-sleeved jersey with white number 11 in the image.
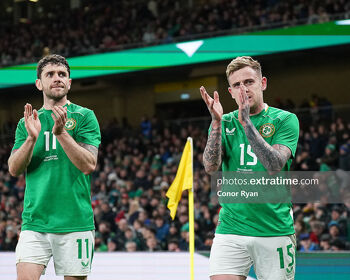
[13,101,101,233]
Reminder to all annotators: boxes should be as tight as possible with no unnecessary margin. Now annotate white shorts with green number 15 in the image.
[209,233,296,280]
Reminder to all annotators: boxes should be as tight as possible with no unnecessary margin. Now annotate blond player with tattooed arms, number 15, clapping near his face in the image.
[200,57,299,280]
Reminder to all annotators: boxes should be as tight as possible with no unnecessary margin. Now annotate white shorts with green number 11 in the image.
[16,230,95,276]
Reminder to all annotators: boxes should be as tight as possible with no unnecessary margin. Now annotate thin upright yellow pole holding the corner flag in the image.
[187,137,194,280]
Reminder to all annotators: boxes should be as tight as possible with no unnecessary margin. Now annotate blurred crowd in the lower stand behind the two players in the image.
[0,101,350,252]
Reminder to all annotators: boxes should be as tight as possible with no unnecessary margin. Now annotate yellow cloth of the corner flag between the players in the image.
[166,137,193,220]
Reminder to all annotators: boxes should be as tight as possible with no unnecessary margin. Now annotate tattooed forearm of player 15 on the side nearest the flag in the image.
[203,123,222,173]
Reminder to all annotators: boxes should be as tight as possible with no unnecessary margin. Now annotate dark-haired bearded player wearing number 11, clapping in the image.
[8,55,101,280]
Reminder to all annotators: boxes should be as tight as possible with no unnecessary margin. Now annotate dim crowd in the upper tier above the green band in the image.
[0,0,350,66]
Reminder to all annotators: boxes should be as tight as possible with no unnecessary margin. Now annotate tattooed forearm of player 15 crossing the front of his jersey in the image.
[244,122,291,171]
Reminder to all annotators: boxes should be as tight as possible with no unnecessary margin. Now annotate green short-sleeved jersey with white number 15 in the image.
[216,104,299,236]
